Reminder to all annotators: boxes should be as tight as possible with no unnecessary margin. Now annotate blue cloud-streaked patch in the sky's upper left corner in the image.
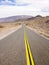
[0,0,29,6]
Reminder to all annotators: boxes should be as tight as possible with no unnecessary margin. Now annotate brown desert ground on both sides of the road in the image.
[0,16,49,38]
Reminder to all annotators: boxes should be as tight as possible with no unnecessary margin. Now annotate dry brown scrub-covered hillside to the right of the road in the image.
[25,16,49,38]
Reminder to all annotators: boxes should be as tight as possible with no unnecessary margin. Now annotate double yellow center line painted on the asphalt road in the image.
[24,29,34,65]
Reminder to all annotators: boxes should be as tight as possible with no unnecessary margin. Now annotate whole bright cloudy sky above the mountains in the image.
[0,0,49,18]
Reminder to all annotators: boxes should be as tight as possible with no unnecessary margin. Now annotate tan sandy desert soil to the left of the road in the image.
[0,22,21,37]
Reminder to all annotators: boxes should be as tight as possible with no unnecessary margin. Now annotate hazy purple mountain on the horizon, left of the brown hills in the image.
[0,15,32,22]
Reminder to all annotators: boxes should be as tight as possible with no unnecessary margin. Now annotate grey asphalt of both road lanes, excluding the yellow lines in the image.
[0,26,49,65]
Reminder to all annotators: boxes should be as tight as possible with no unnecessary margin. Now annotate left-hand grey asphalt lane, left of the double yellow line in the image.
[0,27,26,65]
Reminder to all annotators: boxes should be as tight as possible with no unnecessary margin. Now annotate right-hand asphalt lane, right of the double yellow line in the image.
[26,28,49,65]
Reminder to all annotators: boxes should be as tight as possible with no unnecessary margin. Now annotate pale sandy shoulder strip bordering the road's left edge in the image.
[0,25,22,40]
